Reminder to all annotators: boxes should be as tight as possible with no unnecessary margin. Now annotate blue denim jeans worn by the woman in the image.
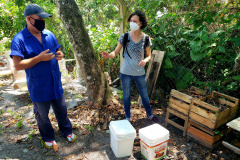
[120,73,152,118]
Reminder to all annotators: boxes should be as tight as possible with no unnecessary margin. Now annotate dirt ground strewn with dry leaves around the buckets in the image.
[0,73,240,160]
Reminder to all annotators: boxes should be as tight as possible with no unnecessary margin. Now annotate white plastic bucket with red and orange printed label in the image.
[139,124,169,160]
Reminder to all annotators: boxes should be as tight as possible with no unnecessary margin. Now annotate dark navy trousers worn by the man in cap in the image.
[33,96,72,141]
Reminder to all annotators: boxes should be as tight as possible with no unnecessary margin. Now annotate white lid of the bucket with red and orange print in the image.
[139,124,169,146]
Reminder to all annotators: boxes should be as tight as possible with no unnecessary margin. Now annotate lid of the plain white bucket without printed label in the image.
[109,120,136,140]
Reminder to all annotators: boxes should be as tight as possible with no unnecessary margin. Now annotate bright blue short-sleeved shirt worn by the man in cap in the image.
[10,25,63,102]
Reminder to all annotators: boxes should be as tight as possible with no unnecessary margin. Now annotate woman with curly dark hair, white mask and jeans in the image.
[101,11,159,123]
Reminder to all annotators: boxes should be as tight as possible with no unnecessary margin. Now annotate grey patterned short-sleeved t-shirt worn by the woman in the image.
[118,32,152,76]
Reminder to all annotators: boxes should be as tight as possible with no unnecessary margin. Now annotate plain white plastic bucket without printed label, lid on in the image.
[109,120,136,158]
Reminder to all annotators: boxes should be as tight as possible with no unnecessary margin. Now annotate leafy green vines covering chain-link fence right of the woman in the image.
[142,1,240,95]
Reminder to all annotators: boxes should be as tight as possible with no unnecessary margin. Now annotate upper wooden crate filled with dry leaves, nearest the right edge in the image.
[189,91,239,129]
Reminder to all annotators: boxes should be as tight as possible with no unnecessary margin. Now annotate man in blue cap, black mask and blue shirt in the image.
[10,4,76,149]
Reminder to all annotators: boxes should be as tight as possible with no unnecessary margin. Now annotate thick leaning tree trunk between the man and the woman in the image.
[55,0,112,105]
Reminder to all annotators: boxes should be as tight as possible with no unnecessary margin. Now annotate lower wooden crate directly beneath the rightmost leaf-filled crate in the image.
[187,119,230,149]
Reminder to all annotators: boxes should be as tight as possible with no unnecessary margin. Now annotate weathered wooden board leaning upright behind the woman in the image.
[138,50,165,106]
